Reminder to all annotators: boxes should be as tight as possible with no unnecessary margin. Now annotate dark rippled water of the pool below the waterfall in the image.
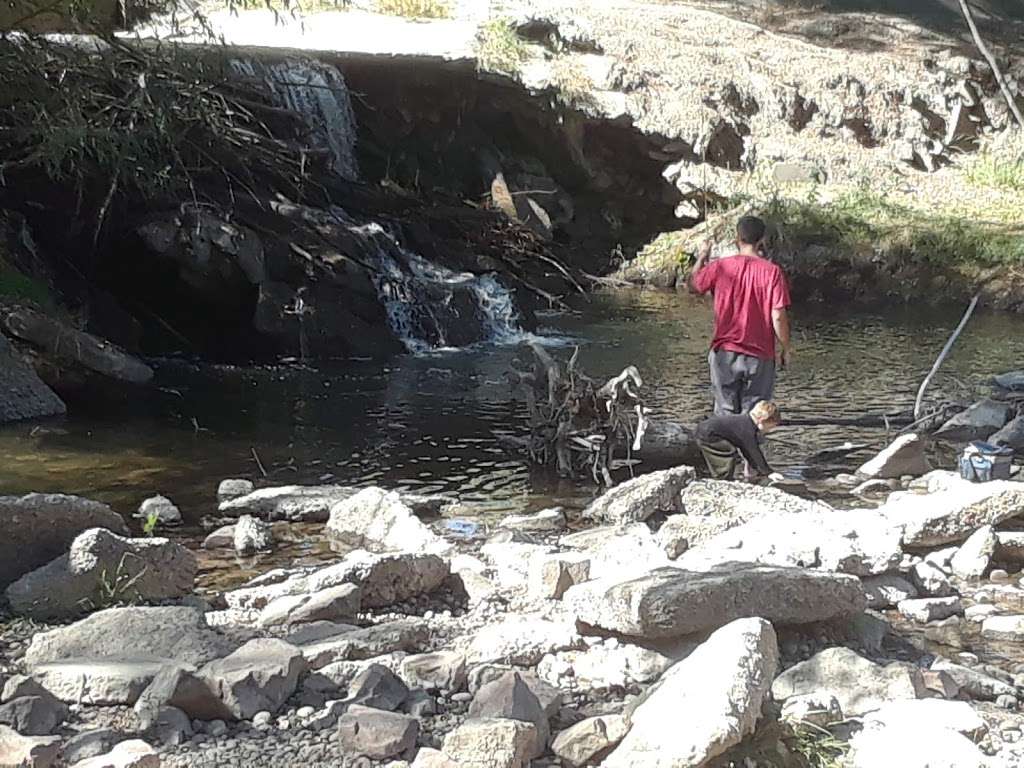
[0,292,1024,522]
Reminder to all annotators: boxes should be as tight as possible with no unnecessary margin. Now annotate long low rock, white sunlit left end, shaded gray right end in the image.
[224,550,450,609]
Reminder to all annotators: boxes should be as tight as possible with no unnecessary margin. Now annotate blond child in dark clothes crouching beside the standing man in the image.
[695,400,782,482]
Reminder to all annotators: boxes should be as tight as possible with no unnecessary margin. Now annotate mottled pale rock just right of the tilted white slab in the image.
[772,648,923,717]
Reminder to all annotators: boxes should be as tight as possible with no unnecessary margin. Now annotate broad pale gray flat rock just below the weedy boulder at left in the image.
[25,606,232,668]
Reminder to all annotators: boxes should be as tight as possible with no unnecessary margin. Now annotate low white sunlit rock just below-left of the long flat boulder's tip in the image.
[467,616,583,667]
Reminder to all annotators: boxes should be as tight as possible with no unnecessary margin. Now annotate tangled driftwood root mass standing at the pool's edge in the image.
[515,344,655,485]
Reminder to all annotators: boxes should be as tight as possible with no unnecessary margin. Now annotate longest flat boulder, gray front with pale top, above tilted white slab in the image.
[564,563,866,639]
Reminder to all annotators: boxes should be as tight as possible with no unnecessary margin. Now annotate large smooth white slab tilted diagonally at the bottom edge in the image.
[602,618,778,768]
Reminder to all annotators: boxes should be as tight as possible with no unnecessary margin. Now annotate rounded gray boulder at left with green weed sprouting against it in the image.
[7,528,199,621]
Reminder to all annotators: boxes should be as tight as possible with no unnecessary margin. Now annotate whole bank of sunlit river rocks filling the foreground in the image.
[0,439,1024,768]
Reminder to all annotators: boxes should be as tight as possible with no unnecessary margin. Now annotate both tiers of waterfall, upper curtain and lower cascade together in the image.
[231,59,524,353]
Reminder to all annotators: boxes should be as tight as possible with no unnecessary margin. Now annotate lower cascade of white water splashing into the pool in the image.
[332,208,523,352]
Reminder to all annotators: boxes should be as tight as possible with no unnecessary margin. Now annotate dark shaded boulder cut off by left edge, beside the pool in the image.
[0,494,128,588]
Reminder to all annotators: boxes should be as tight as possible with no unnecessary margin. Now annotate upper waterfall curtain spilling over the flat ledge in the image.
[230,58,359,181]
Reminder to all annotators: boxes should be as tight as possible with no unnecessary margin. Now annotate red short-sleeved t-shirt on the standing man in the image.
[693,254,790,359]
